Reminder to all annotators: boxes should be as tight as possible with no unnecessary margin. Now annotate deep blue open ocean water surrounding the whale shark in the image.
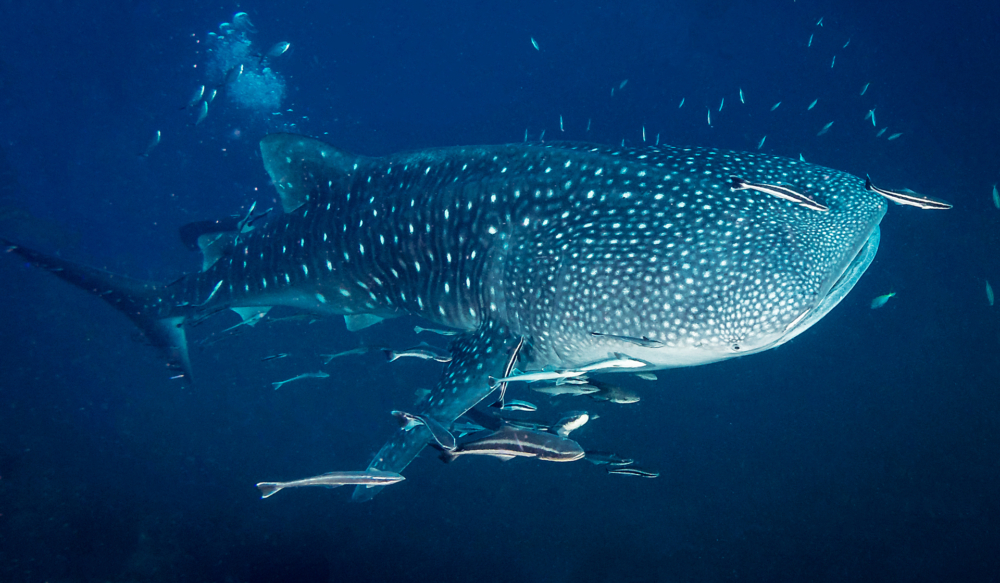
[0,0,1000,583]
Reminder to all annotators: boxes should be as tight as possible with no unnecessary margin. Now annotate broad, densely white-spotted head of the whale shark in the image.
[521,147,887,368]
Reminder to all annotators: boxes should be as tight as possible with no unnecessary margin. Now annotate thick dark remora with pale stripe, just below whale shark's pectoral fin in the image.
[440,425,584,462]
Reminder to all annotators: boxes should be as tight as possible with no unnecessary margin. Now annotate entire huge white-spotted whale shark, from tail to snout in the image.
[7,134,936,499]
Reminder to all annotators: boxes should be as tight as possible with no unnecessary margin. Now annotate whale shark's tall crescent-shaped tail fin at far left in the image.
[0,239,191,382]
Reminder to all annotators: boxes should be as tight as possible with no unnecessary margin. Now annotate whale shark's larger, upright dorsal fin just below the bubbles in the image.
[260,134,364,213]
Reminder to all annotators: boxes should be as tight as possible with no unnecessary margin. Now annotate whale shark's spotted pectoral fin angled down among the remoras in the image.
[352,321,519,502]
